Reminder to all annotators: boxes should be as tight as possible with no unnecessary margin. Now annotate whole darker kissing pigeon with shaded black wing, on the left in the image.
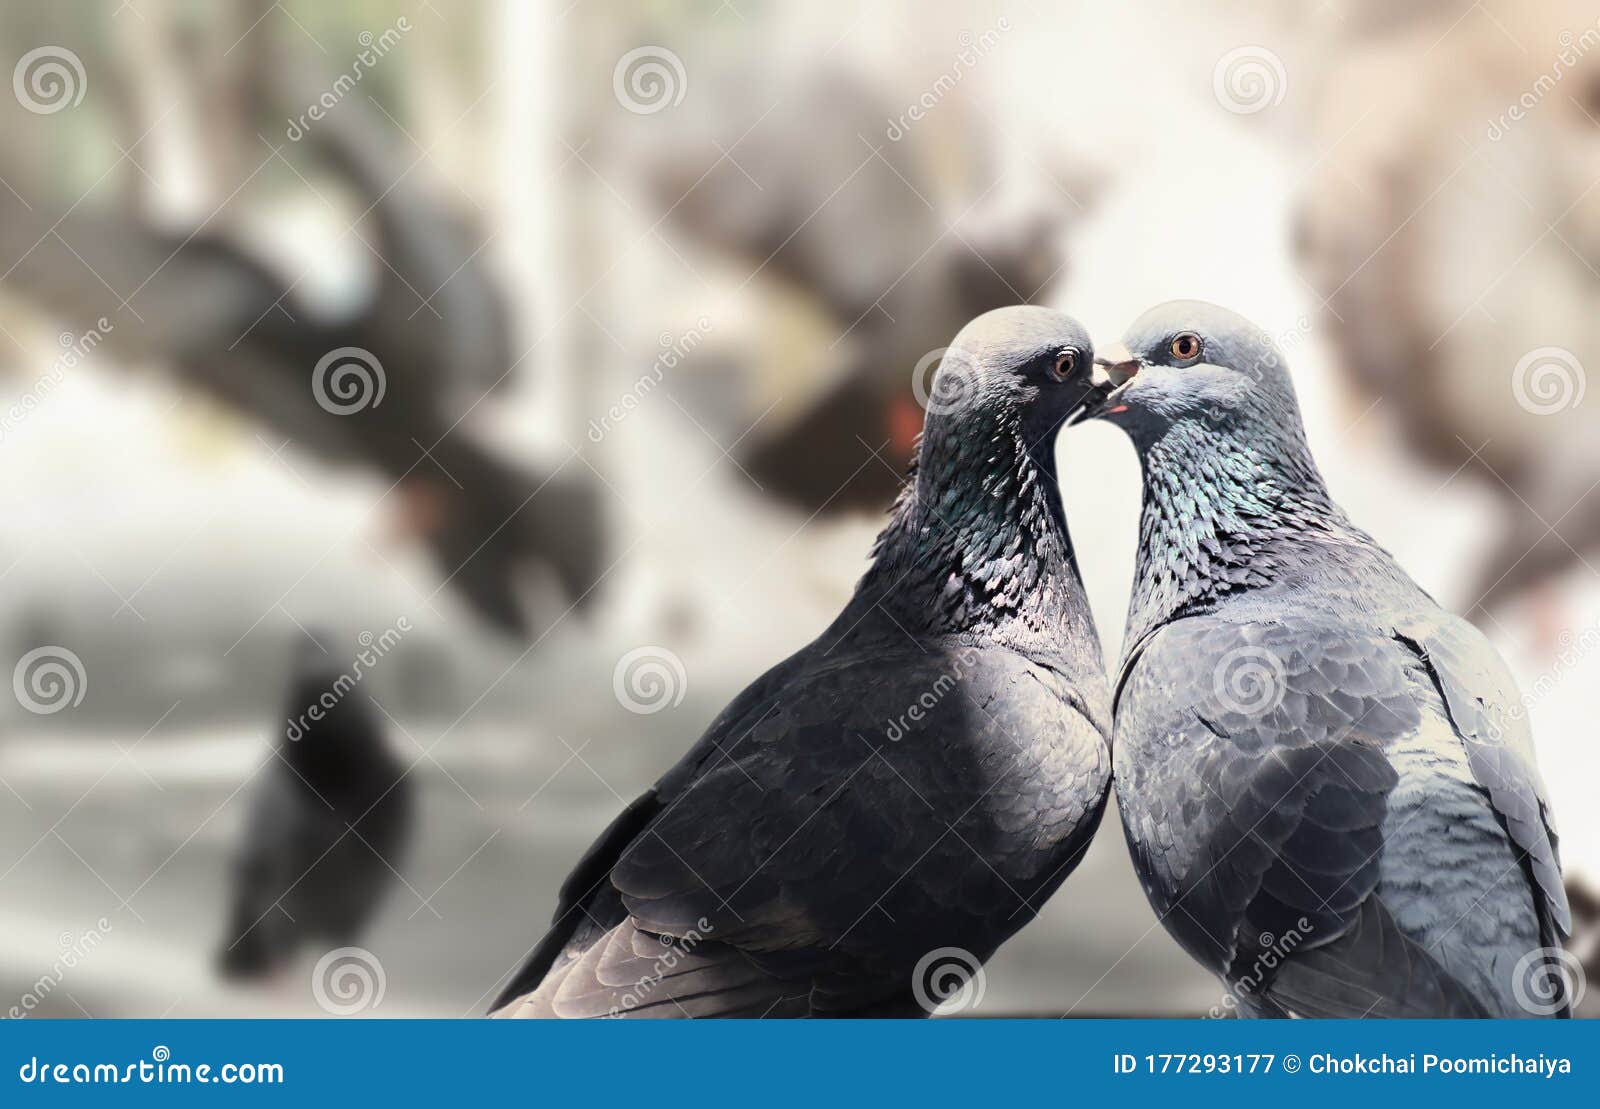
[493,307,1110,1018]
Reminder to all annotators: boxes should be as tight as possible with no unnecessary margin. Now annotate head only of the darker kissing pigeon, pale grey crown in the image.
[926,304,1106,451]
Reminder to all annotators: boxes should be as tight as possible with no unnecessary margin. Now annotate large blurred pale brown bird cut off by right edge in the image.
[1296,0,1600,623]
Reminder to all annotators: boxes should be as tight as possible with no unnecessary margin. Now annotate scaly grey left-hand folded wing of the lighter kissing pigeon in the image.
[1117,616,1482,1016]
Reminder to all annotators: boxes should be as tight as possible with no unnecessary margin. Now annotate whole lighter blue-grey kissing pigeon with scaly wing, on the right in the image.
[1083,301,1571,1018]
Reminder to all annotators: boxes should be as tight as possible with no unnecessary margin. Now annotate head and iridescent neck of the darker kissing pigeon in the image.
[840,306,1104,643]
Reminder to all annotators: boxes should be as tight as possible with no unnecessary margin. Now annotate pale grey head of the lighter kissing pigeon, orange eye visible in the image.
[1082,301,1299,442]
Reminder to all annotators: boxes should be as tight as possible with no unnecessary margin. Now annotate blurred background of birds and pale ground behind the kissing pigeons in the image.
[0,0,1600,1016]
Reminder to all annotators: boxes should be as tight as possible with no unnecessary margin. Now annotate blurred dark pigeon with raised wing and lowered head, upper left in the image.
[0,83,603,632]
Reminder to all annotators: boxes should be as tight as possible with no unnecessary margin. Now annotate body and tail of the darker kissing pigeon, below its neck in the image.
[501,640,1109,1016]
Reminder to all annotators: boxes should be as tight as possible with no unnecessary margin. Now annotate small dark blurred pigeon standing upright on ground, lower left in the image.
[218,643,414,979]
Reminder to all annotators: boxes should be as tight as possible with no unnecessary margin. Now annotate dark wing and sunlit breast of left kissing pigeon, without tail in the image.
[613,640,1109,1010]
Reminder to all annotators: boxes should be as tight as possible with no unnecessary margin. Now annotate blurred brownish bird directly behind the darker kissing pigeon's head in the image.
[630,66,1083,512]
